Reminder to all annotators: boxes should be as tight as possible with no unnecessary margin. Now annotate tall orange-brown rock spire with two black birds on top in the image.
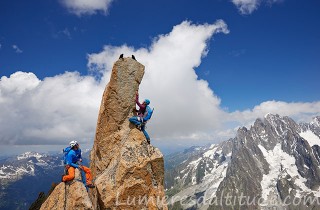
[90,58,167,209]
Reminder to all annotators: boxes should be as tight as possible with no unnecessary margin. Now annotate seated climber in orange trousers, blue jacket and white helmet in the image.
[62,141,94,188]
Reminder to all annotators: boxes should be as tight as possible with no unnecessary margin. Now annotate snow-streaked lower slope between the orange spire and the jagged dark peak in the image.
[165,141,232,209]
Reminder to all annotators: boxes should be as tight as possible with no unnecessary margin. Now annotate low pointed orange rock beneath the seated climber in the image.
[40,170,93,210]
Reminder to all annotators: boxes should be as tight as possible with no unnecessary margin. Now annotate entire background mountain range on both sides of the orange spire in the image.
[0,114,320,210]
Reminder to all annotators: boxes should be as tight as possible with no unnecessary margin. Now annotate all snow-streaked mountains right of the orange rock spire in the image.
[165,114,320,210]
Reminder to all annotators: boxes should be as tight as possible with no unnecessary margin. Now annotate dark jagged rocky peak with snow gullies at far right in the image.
[212,114,320,209]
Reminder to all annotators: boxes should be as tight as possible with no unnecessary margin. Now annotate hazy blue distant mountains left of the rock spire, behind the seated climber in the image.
[0,151,88,210]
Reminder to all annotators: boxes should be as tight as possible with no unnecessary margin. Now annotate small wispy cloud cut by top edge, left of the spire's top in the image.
[60,0,113,16]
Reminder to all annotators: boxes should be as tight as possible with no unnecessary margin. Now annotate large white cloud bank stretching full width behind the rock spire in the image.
[0,21,320,150]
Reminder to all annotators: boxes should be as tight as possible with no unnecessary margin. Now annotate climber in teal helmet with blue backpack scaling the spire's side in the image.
[129,91,153,144]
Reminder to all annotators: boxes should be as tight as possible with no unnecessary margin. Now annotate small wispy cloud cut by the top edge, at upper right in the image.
[232,0,283,15]
